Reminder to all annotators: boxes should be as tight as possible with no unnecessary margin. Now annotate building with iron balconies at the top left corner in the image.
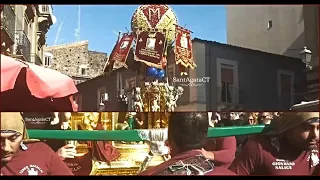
[1,5,56,65]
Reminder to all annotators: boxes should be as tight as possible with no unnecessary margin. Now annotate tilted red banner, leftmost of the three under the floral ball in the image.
[109,33,134,69]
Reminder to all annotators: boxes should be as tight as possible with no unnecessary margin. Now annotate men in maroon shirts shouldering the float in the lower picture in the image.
[1,112,320,176]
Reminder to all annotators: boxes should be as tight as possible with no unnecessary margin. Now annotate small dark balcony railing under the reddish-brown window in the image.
[217,87,239,105]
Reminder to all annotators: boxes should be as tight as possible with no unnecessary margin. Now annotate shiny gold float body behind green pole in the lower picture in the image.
[62,112,167,175]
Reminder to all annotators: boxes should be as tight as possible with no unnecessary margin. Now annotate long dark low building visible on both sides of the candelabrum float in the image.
[77,39,306,111]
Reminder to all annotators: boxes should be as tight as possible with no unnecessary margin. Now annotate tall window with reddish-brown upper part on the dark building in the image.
[221,64,234,103]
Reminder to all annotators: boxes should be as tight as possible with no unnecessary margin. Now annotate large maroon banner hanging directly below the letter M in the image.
[134,31,166,69]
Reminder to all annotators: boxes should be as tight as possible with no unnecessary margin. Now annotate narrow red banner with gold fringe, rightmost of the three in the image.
[175,25,197,75]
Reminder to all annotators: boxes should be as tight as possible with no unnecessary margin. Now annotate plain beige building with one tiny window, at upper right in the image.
[226,5,319,100]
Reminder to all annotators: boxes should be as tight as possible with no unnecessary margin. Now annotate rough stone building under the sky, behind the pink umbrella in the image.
[45,41,108,84]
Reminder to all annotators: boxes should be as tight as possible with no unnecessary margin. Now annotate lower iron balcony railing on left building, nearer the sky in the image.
[16,31,31,62]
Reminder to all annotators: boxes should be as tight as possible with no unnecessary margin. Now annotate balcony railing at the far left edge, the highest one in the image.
[1,5,16,42]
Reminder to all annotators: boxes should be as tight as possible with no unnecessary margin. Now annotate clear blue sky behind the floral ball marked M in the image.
[47,5,226,54]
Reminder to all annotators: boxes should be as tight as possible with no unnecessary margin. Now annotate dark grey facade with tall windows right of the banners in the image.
[193,39,306,111]
